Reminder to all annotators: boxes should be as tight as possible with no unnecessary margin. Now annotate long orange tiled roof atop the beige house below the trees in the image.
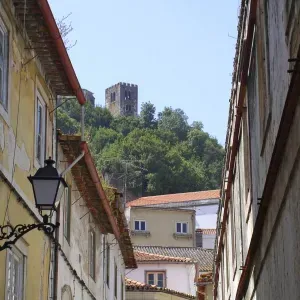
[127,190,220,207]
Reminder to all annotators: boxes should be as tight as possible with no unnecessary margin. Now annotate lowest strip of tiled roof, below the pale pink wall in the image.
[125,278,196,299]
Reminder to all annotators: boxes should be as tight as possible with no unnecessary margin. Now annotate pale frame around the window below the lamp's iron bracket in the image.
[5,246,27,300]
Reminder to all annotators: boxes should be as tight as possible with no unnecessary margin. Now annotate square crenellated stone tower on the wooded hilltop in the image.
[105,82,138,116]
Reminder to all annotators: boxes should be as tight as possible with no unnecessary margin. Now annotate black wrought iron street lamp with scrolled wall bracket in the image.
[0,157,66,251]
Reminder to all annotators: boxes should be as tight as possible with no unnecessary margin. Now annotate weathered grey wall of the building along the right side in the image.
[215,0,300,300]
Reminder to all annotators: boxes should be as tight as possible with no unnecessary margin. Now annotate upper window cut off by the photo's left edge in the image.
[0,20,8,111]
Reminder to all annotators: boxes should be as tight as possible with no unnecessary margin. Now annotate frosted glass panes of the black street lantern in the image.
[32,178,60,210]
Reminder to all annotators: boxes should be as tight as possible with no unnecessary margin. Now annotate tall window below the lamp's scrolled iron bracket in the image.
[5,248,25,300]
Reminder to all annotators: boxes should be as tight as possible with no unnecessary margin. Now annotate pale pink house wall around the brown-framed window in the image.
[128,263,196,295]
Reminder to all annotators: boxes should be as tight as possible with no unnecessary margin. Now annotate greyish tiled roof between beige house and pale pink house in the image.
[133,246,214,272]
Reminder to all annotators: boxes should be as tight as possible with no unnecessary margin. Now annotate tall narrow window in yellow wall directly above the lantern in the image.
[35,92,46,165]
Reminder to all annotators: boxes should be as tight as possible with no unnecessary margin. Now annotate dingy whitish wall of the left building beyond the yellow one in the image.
[55,146,125,300]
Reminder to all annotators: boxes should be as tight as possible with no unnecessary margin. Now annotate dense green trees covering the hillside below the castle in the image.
[57,101,224,196]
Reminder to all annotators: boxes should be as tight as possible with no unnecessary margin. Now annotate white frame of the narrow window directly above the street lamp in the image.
[34,89,47,169]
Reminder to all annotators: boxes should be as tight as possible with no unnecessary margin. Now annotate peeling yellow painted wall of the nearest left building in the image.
[0,1,53,300]
